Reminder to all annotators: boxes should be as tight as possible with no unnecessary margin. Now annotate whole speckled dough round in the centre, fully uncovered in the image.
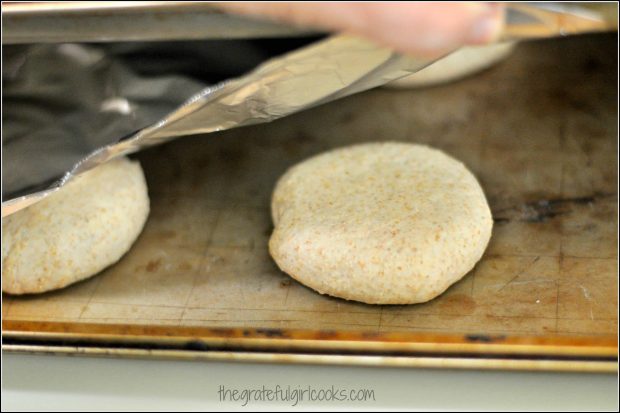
[269,142,493,304]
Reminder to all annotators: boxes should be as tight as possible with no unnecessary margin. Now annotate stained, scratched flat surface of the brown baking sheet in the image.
[2,34,618,366]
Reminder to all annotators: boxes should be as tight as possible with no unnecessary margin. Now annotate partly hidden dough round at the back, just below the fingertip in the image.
[385,43,515,89]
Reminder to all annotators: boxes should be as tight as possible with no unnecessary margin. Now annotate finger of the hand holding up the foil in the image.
[216,2,503,57]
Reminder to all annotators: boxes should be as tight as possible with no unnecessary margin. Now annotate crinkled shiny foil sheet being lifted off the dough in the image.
[2,35,431,216]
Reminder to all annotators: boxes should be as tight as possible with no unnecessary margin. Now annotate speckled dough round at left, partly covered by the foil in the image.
[2,158,149,294]
